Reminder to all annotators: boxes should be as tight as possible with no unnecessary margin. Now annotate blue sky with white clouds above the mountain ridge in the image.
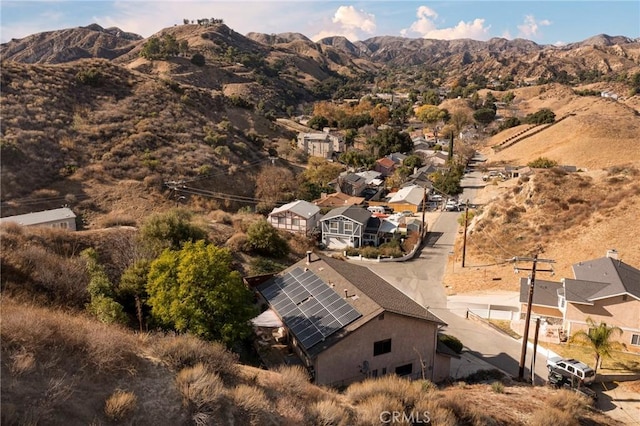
[0,0,640,44]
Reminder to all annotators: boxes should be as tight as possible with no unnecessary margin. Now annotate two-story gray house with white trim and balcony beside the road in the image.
[320,206,371,250]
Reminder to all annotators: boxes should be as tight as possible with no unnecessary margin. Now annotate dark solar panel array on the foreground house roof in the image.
[258,268,362,349]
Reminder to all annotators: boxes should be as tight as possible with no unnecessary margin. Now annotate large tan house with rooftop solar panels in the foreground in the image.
[255,252,452,386]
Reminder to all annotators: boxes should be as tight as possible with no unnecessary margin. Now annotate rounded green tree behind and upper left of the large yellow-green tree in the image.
[140,209,207,253]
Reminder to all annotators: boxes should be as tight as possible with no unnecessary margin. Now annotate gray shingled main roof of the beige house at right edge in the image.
[573,257,640,301]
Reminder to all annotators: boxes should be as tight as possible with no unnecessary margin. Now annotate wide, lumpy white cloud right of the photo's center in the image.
[400,6,491,40]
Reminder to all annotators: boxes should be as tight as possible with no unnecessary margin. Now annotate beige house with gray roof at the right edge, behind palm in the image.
[520,250,640,352]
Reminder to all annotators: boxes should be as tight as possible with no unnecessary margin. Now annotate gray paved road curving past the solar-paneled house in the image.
[367,167,546,382]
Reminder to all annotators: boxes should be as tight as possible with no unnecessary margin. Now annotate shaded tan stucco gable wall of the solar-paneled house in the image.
[314,312,442,386]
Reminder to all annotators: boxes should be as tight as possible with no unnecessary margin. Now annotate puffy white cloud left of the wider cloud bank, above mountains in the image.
[310,6,377,41]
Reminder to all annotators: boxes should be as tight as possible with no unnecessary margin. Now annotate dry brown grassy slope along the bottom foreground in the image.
[0,296,615,426]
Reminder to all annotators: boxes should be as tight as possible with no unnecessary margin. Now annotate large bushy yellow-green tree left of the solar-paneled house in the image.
[147,240,256,345]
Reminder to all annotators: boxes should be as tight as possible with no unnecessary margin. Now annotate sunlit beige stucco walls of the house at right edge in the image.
[564,296,640,352]
